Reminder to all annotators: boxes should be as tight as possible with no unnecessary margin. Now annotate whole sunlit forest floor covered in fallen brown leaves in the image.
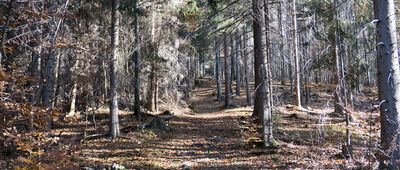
[25,79,379,169]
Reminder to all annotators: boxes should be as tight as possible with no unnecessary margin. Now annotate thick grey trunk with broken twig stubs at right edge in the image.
[374,0,400,169]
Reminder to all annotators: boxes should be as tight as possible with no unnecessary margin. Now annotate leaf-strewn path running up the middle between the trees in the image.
[138,79,251,169]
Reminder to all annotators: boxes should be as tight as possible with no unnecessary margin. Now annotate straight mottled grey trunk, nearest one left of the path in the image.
[109,0,120,139]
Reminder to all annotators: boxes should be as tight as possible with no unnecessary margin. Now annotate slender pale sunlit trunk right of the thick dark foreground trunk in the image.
[292,0,301,108]
